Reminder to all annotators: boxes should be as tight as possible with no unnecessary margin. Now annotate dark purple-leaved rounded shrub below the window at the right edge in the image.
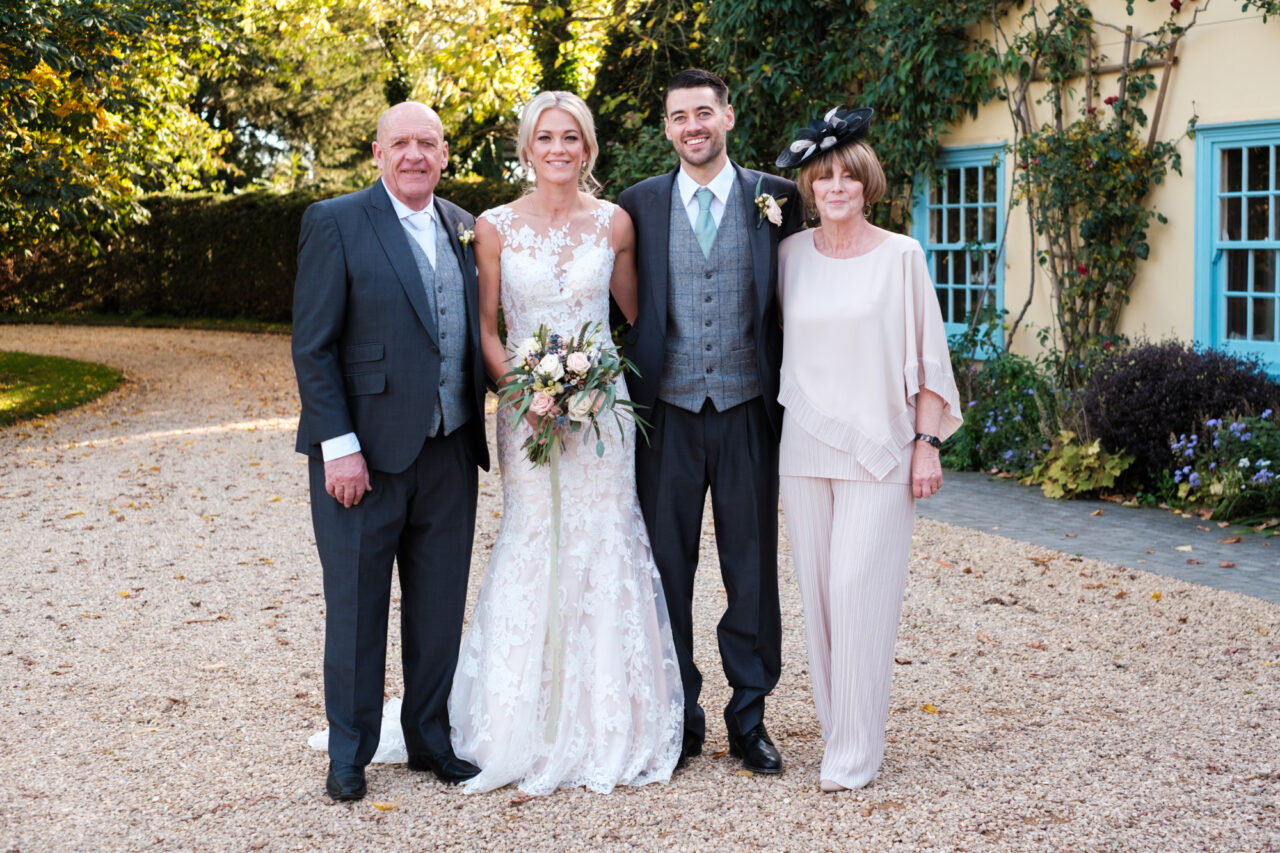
[1080,341,1280,487]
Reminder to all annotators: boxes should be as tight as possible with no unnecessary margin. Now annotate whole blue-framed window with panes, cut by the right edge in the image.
[1196,122,1280,373]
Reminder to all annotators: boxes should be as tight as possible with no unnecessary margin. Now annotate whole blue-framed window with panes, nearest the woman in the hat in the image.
[911,145,1005,341]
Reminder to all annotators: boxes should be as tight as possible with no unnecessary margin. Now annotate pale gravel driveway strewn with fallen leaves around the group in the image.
[0,325,1280,850]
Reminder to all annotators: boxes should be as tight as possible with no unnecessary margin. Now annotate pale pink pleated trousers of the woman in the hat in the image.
[780,476,915,788]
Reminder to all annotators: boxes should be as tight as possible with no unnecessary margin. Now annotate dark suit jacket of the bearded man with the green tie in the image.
[618,163,804,435]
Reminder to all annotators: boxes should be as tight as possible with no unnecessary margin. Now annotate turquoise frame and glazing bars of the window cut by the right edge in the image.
[1193,120,1280,375]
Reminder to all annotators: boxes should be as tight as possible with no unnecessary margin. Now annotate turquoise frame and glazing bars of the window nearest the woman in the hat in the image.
[911,143,1007,350]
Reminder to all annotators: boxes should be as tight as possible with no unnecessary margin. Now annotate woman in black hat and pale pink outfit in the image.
[777,109,960,792]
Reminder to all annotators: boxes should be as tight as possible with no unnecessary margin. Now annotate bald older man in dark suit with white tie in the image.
[293,102,489,800]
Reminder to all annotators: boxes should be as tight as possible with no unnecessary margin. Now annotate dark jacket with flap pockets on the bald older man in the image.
[293,181,489,474]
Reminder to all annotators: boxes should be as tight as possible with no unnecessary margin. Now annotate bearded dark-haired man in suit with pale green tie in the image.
[618,69,803,774]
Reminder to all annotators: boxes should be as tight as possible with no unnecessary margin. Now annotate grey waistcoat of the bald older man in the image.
[408,225,471,435]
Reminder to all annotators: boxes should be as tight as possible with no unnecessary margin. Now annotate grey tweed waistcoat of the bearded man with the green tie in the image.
[658,182,760,411]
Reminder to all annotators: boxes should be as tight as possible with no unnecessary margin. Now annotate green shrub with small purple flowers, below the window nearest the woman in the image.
[943,352,1056,475]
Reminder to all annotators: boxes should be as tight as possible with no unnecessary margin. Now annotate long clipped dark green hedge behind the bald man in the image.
[0,178,521,323]
